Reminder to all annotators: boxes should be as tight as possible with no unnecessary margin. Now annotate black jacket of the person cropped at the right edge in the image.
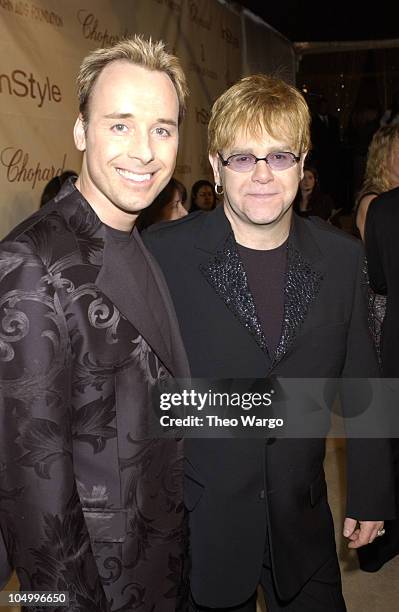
[365,187,399,378]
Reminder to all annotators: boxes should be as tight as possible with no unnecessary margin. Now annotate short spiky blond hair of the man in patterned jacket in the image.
[77,36,188,126]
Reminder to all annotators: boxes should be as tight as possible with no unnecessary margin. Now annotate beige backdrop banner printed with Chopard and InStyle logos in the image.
[0,0,295,238]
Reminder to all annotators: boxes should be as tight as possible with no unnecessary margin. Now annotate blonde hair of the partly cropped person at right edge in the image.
[356,125,399,204]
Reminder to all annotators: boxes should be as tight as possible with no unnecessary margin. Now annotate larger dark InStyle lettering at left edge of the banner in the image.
[0,69,62,108]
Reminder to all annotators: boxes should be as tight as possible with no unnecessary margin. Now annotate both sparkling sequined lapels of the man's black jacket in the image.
[196,207,323,367]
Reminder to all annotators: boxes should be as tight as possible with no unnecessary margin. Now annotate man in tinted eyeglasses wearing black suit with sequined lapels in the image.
[145,75,394,612]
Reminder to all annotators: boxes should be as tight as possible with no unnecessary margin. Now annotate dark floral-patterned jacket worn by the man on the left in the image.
[0,183,188,612]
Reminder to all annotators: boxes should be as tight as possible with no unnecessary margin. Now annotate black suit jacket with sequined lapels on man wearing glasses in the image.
[144,207,394,607]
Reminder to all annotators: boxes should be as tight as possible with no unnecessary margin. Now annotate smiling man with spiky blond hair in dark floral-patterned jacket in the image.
[0,37,188,612]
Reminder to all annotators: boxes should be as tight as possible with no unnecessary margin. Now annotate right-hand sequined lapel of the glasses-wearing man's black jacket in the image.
[272,218,323,367]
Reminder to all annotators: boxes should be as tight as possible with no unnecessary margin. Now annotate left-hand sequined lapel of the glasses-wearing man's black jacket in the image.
[200,233,267,351]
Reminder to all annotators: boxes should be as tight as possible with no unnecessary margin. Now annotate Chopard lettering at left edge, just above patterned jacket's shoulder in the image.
[0,147,67,189]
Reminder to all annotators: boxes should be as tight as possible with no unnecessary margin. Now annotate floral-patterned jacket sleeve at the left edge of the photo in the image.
[0,242,108,612]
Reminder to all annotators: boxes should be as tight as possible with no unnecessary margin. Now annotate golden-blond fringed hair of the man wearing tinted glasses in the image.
[208,74,310,155]
